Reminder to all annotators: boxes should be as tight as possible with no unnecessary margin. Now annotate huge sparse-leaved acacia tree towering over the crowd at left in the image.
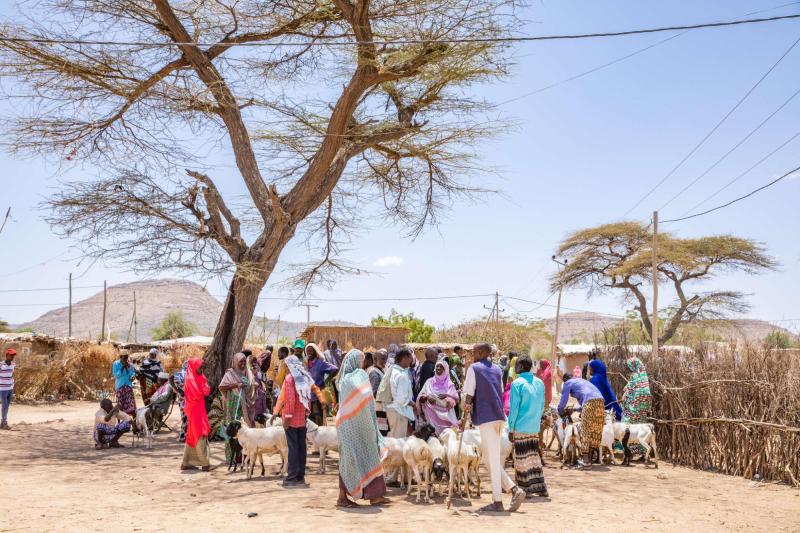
[0,0,519,382]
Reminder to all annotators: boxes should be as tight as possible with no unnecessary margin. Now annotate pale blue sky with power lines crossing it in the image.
[0,0,800,329]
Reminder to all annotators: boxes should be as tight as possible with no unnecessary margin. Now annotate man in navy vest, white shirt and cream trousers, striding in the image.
[461,344,525,512]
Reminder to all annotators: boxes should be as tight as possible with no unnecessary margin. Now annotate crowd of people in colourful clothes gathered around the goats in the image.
[89,339,651,511]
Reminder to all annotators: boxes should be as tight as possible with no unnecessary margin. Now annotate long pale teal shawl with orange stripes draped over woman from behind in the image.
[336,349,383,499]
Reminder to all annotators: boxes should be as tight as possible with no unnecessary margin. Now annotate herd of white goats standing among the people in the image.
[226,408,658,503]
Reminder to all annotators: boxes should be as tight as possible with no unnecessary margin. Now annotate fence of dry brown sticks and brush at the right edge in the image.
[607,340,800,486]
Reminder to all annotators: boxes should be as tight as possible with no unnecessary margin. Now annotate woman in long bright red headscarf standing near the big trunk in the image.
[181,357,211,471]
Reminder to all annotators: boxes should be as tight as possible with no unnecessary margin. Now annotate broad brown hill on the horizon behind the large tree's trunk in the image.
[18,279,360,342]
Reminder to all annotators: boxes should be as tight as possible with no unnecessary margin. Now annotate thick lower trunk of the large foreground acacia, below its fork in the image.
[204,269,272,388]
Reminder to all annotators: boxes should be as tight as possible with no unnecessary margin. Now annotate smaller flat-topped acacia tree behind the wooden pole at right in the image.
[550,222,777,343]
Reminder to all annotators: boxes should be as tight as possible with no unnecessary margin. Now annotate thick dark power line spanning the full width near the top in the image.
[0,15,800,48]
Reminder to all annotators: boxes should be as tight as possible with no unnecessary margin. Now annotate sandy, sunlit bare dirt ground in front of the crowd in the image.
[0,402,800,532]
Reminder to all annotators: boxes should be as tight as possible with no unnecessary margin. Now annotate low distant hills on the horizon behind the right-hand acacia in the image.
[545,312,796,342]
